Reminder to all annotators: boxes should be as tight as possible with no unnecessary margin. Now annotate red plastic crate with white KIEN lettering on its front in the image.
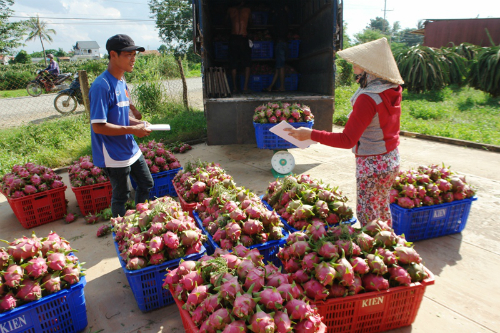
[312,269,434,333]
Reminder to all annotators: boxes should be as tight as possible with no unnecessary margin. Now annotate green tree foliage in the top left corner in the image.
[0,0,25,53]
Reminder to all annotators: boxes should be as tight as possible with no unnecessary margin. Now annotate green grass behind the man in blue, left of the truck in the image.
[0,104,206,176]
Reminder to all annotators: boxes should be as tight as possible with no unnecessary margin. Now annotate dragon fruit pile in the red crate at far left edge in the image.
[0,163,64,199]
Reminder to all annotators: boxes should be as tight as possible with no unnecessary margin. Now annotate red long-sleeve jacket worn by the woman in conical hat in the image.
[311,86,403,156]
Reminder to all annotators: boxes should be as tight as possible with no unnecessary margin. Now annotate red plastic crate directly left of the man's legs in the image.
[71,181,113,216]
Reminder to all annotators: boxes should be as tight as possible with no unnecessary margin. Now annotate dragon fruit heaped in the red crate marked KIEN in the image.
[278,220,428,301]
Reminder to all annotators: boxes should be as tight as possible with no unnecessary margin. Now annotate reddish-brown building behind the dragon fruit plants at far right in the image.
[412,18,500,48]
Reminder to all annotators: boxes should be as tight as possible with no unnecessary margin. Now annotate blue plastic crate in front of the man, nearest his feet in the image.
[113,233,206,312]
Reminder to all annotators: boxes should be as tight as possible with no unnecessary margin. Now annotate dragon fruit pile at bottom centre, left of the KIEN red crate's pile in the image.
[164,245,326,333]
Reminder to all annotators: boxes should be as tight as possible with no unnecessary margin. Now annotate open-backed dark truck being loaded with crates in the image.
[193,0,343,145]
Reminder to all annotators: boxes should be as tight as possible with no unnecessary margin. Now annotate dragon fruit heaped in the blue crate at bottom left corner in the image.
[0,232,84,313]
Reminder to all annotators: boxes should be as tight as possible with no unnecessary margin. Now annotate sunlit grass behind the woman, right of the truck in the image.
[333,85,500,145]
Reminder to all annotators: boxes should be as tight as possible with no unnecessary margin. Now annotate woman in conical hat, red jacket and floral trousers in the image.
[289,38,403,225]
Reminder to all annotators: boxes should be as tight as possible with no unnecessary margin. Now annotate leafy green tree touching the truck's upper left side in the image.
[149,0,193,57]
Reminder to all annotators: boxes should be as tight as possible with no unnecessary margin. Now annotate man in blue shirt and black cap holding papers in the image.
[89,35,154,217]
